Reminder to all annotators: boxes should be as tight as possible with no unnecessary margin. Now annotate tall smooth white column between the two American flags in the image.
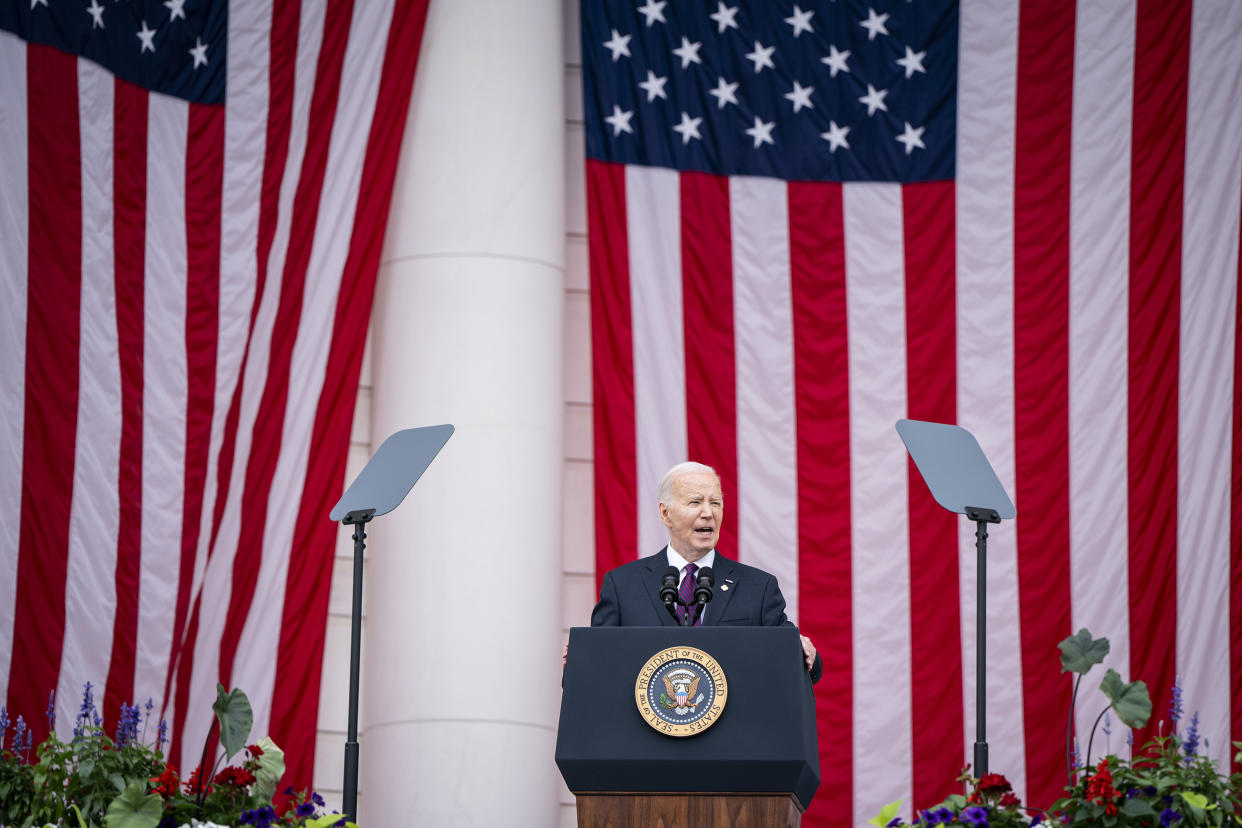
[359,0,565,826]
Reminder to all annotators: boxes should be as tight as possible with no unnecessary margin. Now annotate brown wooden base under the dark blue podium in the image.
[576,793,802,828]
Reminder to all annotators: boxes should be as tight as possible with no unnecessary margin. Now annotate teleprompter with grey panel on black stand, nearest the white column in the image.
[329,425,453,822]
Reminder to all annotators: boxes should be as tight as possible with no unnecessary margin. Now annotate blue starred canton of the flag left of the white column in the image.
[0,0,229,104]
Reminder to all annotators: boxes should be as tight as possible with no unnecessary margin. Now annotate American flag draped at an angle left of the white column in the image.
[0,0,427,786]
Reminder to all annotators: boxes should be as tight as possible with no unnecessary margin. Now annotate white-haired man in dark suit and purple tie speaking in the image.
[591,463,823,682]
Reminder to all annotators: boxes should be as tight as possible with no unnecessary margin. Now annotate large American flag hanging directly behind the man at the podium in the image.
[581,0,1242,824]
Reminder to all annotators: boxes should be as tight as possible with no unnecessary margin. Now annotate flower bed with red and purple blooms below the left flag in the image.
[0,682,358,828]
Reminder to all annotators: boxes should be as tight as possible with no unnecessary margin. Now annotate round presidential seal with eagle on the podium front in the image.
[633,647,729,736]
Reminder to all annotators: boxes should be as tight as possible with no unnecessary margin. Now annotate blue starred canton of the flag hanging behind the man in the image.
[582,0,958,182]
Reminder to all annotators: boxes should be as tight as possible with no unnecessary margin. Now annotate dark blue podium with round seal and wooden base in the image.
[556,627,820,828]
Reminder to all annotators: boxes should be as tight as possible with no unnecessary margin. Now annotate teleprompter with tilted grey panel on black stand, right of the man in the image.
[897,420,1017,777]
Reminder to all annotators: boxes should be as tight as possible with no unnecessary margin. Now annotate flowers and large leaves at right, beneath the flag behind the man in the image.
[871,629,1242,828]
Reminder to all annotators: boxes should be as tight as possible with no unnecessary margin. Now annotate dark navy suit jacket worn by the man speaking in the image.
[591,549,823,682]
